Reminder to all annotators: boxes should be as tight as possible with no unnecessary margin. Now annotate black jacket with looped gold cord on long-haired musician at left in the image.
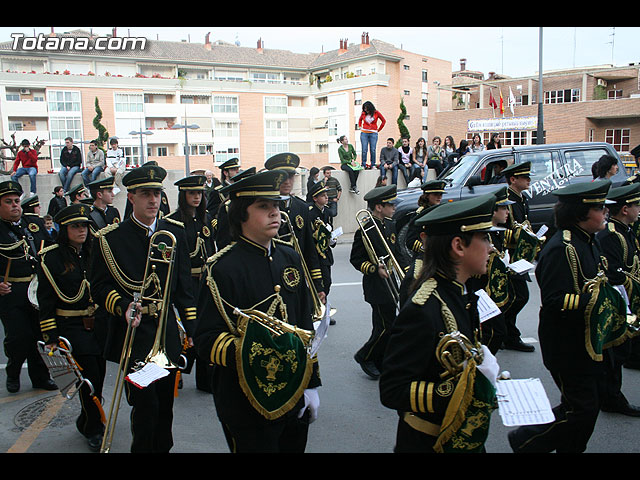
[37,244,102,355]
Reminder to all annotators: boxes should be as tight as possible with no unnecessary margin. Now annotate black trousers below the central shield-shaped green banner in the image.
[220,410,309,453]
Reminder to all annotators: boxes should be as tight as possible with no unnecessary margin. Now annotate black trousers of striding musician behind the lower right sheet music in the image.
[510,371,606,453]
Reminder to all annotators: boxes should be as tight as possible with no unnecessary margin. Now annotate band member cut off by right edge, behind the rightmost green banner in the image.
[596,183,640,417]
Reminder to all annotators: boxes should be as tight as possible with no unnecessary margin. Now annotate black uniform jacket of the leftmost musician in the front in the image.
[0,215,53,310]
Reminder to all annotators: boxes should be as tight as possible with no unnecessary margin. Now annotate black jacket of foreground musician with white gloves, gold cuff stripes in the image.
[379,274,479,425]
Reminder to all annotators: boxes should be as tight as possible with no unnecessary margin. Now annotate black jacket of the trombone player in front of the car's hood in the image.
[349,217,406,304]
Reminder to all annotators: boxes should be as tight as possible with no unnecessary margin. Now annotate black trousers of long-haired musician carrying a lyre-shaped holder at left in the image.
[73,355,106,437]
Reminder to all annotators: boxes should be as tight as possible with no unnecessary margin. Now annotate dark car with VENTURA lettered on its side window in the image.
[394,142,627,260]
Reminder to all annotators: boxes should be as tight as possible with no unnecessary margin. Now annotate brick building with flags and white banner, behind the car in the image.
[430,59,640,156]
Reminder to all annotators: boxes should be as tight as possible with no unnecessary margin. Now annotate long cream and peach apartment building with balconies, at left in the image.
[0,29,451,172]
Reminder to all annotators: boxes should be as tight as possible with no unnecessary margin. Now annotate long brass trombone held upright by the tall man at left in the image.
[100,230,178,453]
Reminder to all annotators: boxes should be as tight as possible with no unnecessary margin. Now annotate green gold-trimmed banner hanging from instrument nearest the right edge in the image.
[583,276,629,361]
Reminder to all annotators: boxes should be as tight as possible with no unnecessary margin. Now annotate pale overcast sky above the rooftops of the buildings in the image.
[0,26,640,77]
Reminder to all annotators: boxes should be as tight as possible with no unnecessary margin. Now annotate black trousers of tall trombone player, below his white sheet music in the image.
[125,369,176,453]
